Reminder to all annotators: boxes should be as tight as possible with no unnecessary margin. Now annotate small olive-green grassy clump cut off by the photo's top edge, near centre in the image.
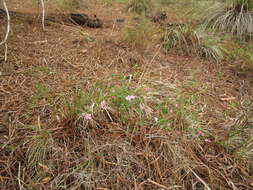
[127,0,153,14]
